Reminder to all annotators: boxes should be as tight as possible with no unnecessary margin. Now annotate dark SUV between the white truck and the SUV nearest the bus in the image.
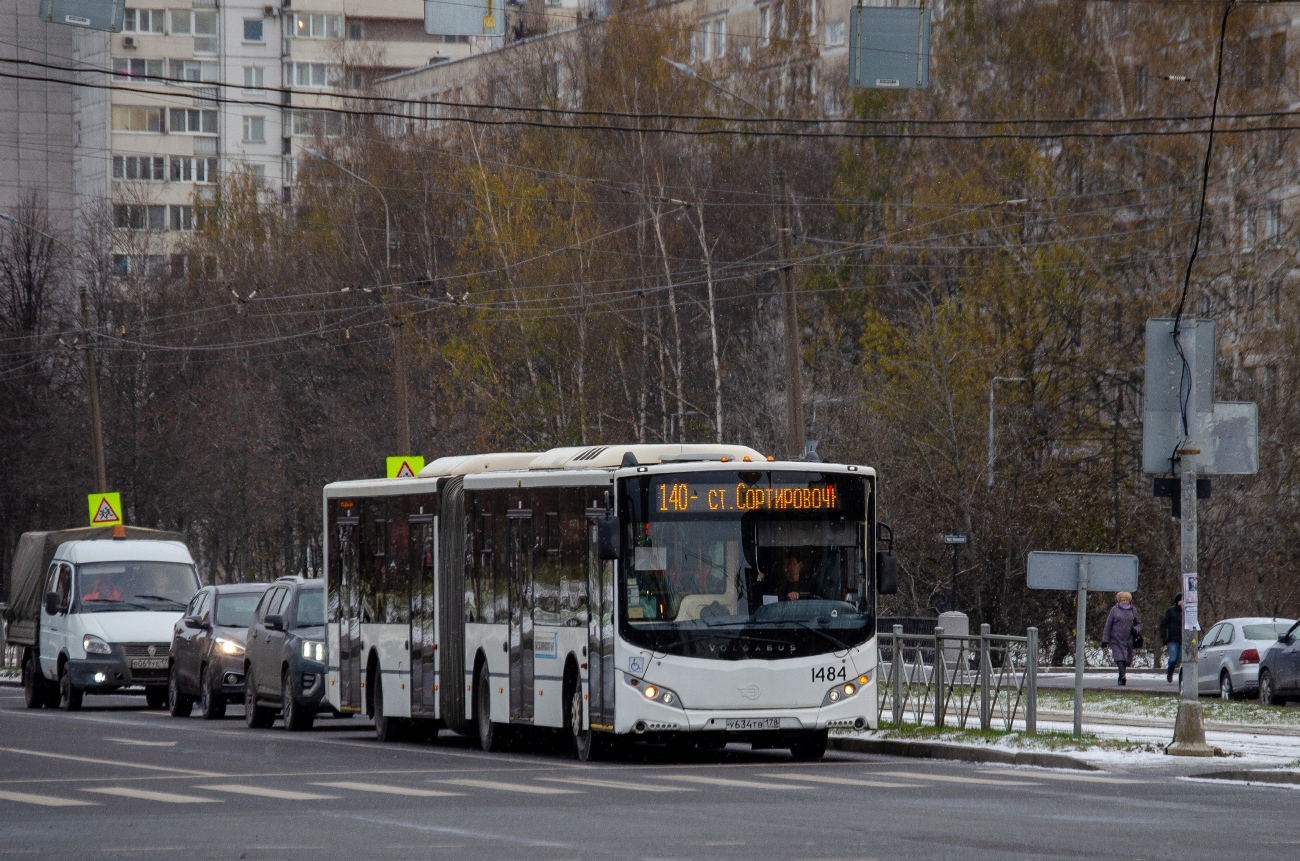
[166,583,270,721]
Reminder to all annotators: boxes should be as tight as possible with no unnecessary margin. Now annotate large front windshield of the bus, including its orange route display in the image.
[619,470,875,659]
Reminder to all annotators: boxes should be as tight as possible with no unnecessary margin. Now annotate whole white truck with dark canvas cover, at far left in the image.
[4,527,199,709]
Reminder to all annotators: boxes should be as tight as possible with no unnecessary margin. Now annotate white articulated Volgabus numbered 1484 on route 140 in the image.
[324,445,897,760]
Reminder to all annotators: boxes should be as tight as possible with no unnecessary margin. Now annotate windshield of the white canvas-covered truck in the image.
[77,562,199,613]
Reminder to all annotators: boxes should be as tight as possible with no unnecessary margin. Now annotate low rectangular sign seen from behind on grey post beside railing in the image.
[1026,556,1138,737]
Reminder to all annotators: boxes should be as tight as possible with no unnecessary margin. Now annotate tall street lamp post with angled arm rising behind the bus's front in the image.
[659,57,807,458]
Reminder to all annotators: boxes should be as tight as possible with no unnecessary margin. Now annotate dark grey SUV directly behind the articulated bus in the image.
[244,577,325,730]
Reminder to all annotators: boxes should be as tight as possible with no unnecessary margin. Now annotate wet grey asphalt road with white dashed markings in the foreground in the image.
[0,688,1300,861]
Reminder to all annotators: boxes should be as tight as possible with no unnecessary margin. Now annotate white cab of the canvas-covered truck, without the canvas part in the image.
[23,538,199,710]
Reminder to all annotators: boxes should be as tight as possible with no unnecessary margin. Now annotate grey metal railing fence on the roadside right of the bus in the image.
[876,624,1039,734]
